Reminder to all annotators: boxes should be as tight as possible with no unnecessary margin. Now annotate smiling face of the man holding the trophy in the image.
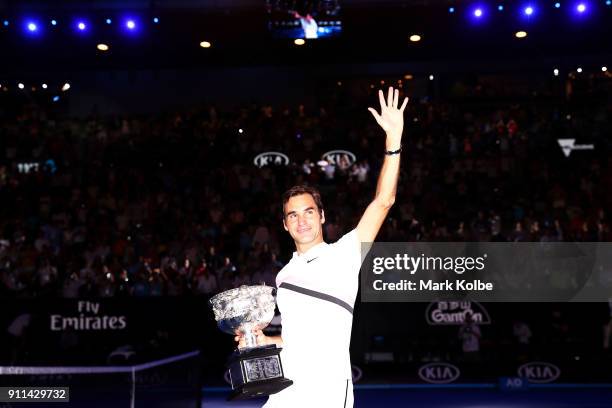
[283,194,325,249]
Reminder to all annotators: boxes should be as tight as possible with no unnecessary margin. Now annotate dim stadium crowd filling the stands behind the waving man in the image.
[0,81,612,297]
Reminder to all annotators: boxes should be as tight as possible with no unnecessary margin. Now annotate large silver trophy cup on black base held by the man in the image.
[209,285,293,399]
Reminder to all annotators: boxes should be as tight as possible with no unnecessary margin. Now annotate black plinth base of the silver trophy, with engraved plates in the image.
[227,345,293,401]
